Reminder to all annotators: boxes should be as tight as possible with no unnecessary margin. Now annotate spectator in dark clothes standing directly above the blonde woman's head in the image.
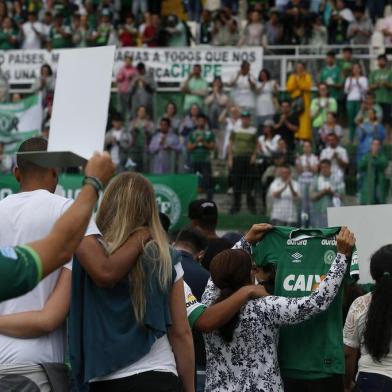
[129,105,154,173]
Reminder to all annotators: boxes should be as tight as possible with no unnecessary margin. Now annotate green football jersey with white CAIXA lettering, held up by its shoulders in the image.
[253,227,359,379]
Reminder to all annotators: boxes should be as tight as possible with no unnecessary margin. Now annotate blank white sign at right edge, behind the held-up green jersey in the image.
[328,204,392,283]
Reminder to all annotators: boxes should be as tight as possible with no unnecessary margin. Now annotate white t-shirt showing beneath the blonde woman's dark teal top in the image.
[90,263,184,382]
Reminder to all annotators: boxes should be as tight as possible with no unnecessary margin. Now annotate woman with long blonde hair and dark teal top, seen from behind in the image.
[70,173,194,392]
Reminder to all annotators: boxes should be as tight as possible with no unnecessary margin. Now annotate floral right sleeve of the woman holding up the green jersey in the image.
[265,254,347,325]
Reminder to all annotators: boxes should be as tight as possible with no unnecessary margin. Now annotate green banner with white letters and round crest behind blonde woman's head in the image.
[0,174,198,230]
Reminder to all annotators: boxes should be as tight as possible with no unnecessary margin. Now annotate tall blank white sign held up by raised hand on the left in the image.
[48,46,115,159]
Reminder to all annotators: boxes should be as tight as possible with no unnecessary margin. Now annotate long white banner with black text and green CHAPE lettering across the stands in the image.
[0,46,263,84]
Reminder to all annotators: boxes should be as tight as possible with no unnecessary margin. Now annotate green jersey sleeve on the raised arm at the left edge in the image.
[0,246,42,302]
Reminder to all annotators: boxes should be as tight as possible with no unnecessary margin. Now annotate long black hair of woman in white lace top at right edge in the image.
[364,245,392,362]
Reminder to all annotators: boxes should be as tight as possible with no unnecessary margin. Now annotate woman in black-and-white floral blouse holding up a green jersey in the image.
[203,228,355,392]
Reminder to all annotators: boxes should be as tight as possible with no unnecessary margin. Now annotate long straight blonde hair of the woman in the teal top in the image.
[97,173,172,324]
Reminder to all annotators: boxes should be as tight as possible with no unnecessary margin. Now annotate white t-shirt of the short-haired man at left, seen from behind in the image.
[0,189,99,364]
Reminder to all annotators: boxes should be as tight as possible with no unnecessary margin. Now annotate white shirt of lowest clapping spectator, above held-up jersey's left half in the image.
[269,178,300,223]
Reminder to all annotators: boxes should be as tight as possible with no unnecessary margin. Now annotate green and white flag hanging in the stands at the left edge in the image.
[0,94,43,153]
